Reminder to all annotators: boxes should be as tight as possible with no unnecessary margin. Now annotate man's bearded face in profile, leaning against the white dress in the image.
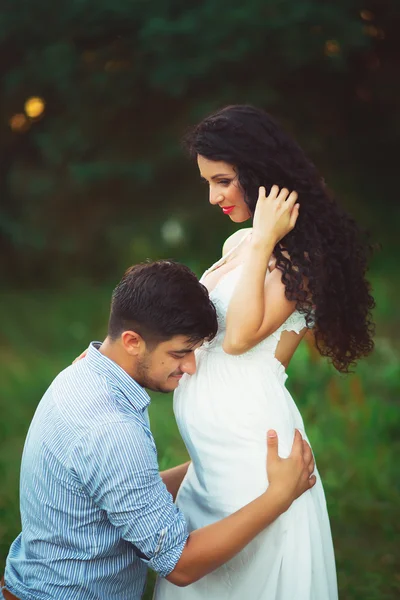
[135,335,203,392]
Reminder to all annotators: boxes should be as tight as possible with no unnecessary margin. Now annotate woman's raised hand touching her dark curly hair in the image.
[251,185,300,246]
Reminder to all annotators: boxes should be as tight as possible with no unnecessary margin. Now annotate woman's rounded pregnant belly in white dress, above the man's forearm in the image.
[174,355,303,526]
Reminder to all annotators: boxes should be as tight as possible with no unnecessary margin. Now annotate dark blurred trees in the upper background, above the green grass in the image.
[0,0,400,285]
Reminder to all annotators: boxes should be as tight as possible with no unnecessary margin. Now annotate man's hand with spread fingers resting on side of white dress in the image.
[267,429,316,510]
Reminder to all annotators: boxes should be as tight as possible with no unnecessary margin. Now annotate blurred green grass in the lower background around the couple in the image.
[0,277,400,600]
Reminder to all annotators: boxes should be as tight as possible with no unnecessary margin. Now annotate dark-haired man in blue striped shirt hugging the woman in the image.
[2,261,315,600]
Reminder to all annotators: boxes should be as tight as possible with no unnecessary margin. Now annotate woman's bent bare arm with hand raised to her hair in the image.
[223,186,299,354]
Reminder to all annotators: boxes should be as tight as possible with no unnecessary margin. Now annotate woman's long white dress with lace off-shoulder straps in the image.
[154,244,338,600]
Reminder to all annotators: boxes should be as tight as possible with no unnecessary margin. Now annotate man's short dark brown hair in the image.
[108,260,218,346]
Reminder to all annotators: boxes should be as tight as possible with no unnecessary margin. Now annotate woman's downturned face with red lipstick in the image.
[197,154,251,223]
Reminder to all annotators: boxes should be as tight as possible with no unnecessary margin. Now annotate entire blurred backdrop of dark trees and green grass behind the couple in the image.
[0,0,400,600]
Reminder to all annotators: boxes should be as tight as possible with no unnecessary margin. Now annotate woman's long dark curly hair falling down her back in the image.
[184,105,374,373]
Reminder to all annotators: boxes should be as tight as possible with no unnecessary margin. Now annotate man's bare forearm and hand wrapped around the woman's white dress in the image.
[167,430,316,587]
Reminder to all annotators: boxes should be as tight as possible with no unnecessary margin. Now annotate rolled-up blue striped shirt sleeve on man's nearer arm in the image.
[71,419,189,577]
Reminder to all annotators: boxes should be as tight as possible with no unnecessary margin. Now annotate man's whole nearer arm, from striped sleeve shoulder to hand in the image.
[71,418,315,586]
